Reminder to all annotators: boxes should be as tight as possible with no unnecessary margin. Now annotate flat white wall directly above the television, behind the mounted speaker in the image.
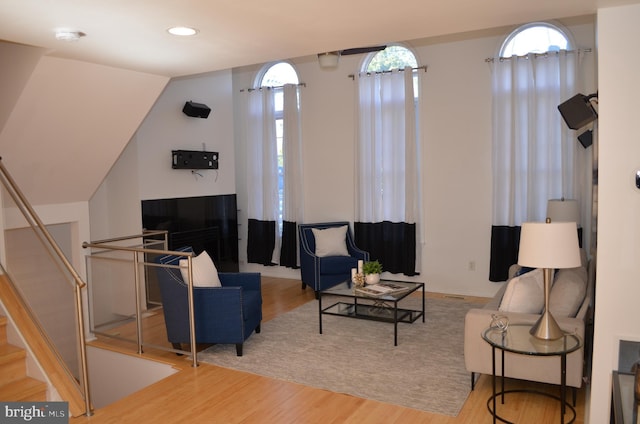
[136,71,236,200]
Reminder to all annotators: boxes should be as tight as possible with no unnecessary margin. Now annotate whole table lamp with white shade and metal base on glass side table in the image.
[518,218,580,340]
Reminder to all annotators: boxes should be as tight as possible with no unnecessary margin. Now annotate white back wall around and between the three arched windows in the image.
[233,17,595,296]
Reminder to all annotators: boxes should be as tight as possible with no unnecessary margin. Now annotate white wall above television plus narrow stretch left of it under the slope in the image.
[90,71,236,240]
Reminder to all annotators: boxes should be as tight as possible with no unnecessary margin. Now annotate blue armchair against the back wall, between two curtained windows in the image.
[298,221,369,295]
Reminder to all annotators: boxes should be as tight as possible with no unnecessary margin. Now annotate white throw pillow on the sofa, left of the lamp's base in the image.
[498,269,544,314]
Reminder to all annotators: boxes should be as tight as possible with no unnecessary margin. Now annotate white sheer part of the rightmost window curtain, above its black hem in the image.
[492,51,582,226]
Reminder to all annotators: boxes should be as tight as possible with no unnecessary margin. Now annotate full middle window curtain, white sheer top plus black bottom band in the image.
[354,67,422,275]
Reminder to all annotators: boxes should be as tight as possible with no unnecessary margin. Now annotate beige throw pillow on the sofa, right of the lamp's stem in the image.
[549,268,587,318]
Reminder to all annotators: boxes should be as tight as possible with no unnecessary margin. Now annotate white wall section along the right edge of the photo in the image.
[589,5,640,423]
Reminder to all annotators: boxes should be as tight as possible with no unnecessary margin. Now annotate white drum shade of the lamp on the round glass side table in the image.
[518,221,580,268]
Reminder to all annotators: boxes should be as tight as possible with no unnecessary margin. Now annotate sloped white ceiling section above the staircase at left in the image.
[0,50,168,205]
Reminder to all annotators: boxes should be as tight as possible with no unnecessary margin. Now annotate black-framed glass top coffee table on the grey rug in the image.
[318,280,425,346]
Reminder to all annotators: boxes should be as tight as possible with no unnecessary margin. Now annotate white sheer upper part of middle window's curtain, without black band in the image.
[355,68,420,223]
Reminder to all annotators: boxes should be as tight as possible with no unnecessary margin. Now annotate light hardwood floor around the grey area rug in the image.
[70,277,585,424]
